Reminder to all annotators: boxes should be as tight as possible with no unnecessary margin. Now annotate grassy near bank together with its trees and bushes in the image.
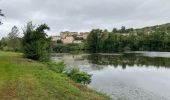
[0,18,110,100]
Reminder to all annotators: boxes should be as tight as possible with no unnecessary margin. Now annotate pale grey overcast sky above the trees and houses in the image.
[0,0,170,37]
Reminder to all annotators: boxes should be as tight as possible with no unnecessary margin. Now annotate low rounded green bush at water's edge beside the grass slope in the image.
[66,68,92,84]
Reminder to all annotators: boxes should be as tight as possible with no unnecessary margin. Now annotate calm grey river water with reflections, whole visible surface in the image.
[52,52,170,100]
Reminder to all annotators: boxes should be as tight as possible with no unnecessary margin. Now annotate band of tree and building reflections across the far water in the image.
[53,53,170,70]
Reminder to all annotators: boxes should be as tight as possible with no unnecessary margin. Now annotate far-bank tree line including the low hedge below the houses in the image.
[53,24,170,53]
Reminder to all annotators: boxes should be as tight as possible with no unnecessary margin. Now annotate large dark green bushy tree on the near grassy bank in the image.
[23,22,51,61]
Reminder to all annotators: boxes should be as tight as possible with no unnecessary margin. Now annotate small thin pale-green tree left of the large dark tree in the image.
[7,26,21,51]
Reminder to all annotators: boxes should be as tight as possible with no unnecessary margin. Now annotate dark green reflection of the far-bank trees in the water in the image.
[83,53,170,69]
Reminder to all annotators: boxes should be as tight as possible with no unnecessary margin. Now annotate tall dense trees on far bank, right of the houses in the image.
[85,27,170,53]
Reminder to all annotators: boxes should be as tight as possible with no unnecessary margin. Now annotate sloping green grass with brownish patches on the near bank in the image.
[0,51,109,100]
